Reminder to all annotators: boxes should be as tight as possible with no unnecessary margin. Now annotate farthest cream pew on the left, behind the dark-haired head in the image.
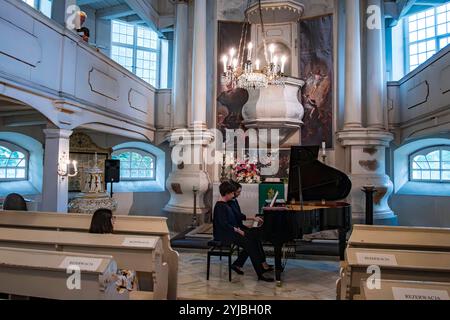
[0,211,178,300]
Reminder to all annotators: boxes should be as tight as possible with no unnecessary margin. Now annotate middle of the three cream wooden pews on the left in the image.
[0,228,168,300]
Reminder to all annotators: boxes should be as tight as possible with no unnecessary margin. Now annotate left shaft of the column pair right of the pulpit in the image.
[344,0,361,129]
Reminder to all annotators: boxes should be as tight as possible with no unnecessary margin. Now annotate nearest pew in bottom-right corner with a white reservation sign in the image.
[361,280,450,301]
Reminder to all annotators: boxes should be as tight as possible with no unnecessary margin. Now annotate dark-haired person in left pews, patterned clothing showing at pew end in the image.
[89,209,137,292]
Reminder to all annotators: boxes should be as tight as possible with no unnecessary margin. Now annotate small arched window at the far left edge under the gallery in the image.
[0,141,28,181]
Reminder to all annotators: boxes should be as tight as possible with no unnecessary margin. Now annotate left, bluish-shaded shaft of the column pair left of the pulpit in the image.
[172,0,189,129]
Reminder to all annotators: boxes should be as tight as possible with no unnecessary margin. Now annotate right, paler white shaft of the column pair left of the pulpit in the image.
[191,0,206,128]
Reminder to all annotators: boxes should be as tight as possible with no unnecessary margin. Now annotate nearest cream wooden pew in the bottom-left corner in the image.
[0,247,129,300]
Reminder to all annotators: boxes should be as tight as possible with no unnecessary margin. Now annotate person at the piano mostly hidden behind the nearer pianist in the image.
[228,181,273,274]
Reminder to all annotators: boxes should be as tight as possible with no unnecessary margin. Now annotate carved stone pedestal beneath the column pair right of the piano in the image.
[338,129,396,224]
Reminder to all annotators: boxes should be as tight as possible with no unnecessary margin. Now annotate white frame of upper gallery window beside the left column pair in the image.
[110,19,161,88]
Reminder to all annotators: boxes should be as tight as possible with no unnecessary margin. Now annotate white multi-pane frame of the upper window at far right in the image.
[403,3,450,73]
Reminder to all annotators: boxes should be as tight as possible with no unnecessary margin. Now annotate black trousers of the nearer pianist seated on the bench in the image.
[233,228,266,275]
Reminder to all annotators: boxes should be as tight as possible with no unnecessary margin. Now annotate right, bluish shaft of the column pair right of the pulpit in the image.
[366,0,386,129]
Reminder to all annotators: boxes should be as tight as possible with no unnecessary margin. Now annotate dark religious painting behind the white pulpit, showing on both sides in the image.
[216,15,333,179]
